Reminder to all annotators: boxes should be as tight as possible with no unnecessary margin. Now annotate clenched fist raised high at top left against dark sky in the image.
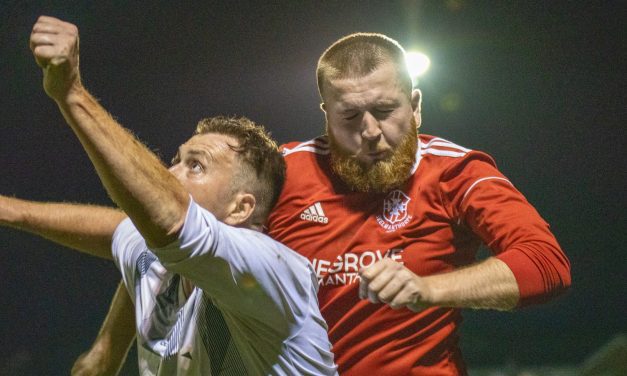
[30,16,81,101]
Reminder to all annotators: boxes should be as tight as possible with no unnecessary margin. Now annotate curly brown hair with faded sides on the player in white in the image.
[194,116,285,225]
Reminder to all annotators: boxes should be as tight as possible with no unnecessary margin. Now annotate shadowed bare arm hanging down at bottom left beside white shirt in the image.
[72,282,135,376]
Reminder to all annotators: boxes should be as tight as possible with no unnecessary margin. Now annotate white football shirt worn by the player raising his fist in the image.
[113,201,337,375]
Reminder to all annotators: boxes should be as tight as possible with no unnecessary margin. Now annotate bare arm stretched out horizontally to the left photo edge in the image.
[0,196,126,259]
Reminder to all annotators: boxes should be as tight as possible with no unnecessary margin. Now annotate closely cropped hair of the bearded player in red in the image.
[316,33,412,100]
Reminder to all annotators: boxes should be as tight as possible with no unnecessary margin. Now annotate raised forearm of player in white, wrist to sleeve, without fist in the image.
[57,87,189,246]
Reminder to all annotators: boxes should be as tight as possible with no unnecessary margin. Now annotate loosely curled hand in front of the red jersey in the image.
[359,258,432,312]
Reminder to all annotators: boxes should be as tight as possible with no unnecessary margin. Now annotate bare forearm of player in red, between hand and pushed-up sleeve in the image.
[423,257,519,310]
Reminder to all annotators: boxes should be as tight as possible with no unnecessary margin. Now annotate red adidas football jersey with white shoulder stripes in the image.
[268,135,570,376]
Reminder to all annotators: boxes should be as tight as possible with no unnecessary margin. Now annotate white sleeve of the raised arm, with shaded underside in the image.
[152,200,317,325]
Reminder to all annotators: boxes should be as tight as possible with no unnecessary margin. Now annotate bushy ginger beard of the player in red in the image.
[327,118,418,193]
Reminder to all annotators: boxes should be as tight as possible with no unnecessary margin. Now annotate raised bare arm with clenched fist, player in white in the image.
[30,16,189,247]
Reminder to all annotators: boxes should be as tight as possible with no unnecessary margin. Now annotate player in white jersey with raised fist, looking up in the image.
[0,16,337,375]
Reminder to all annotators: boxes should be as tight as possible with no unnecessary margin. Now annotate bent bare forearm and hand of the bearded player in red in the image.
[359,257,519,311]
